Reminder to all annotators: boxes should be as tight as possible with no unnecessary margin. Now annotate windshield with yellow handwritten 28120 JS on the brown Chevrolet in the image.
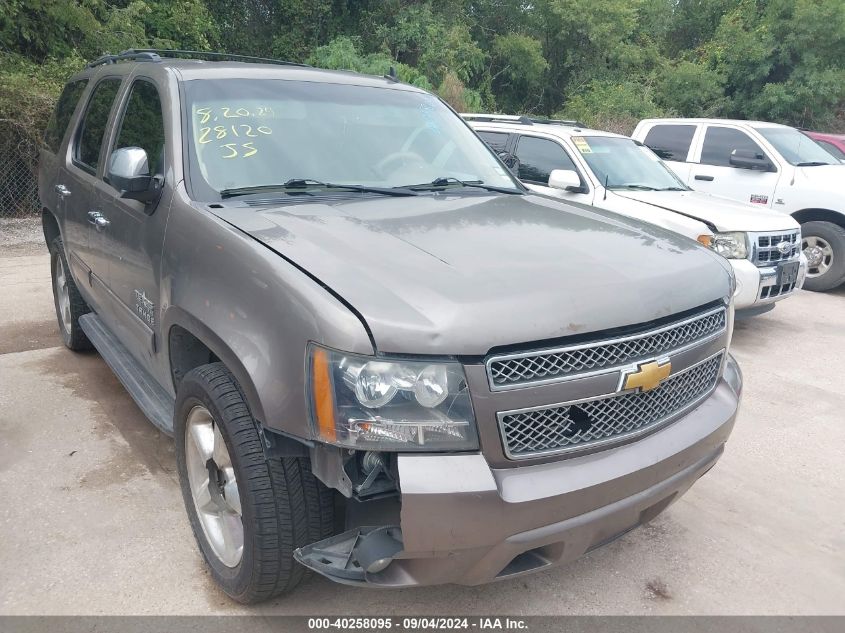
[185,79,518,199]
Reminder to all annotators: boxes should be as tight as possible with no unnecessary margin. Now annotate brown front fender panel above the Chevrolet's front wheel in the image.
[160,185,374,437]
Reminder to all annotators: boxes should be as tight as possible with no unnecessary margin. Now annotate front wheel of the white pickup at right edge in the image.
[801,222,845,292]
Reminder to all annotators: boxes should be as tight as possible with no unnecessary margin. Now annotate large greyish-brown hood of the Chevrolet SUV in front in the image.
[213,194,730,355]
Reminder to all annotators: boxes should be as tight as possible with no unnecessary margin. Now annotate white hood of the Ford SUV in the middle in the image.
[613,190,799,232]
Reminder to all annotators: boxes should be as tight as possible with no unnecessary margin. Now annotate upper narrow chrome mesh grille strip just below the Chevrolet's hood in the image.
[487,308,726,391]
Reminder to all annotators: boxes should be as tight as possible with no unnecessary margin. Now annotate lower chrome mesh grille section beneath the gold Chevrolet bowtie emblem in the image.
[499,352,723,459]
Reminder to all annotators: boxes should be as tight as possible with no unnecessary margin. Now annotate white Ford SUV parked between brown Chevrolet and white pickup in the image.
[462,114,806,314]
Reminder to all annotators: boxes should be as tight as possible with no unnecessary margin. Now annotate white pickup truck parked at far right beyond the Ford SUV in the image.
[632,119,845,291]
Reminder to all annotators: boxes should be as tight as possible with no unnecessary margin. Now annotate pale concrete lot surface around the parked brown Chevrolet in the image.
[0,239,845,615]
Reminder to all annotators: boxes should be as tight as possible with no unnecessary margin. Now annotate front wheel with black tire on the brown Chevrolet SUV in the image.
[174,363,333,604]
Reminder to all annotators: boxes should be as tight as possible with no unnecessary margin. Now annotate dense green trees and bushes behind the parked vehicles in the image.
[0,0,845,139]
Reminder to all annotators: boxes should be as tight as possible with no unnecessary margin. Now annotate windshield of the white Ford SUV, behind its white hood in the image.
[572,136,687,191]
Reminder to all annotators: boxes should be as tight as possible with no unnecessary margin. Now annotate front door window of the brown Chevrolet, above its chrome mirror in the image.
[114,80,164,175]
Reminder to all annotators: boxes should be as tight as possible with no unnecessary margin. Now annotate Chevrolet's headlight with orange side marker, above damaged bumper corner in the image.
[308,345,478,451]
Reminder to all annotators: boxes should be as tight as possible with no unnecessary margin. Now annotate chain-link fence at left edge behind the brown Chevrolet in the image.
[0,121,39,218]
